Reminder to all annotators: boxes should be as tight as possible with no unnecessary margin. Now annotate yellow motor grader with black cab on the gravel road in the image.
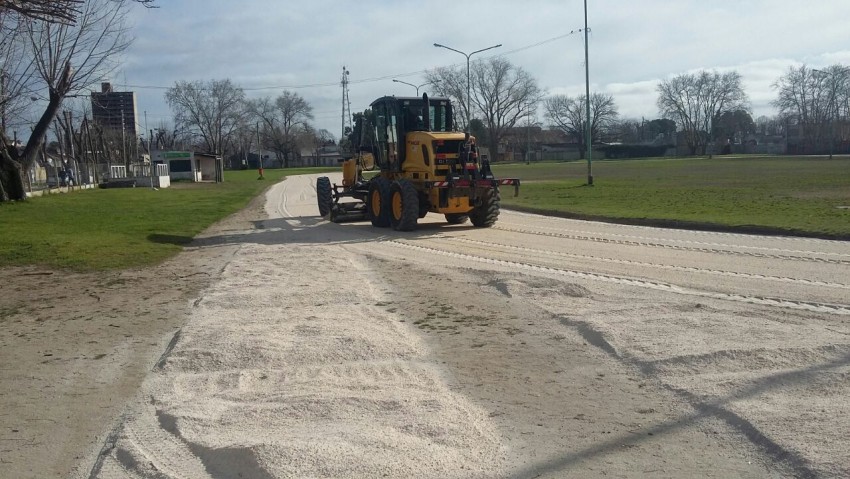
[316,94,519,231]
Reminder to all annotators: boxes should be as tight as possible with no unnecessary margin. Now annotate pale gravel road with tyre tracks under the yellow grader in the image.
[88,176,850,478]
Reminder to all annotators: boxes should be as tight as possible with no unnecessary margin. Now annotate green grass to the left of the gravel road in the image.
[0,168,335,270]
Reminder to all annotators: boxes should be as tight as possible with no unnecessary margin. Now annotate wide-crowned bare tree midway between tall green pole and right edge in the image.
[657,71,748,156]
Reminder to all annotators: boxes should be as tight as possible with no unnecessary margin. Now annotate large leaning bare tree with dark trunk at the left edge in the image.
[0,0,130,201]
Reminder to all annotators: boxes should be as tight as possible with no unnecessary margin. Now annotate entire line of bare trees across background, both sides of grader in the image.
[0,0,850,201]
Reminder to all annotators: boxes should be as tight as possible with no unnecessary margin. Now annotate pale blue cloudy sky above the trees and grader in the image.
[111,0,850,138]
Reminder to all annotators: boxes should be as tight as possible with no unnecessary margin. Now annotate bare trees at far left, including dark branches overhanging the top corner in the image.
[0,0,155,201]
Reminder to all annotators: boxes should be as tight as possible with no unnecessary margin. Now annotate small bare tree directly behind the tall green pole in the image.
[543,93,619,158]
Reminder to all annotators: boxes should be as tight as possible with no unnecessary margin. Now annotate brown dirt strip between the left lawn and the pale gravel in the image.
[0,198,264,478]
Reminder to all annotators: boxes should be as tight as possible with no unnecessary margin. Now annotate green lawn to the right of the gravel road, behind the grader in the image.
[493,156,850,239]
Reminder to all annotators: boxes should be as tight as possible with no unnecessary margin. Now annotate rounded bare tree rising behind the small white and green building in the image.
[165,80,245,155]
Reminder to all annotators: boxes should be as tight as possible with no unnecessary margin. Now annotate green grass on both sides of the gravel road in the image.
[0,157,850,270]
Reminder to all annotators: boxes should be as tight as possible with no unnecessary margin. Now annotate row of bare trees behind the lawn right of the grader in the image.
[426,57,850,161]
